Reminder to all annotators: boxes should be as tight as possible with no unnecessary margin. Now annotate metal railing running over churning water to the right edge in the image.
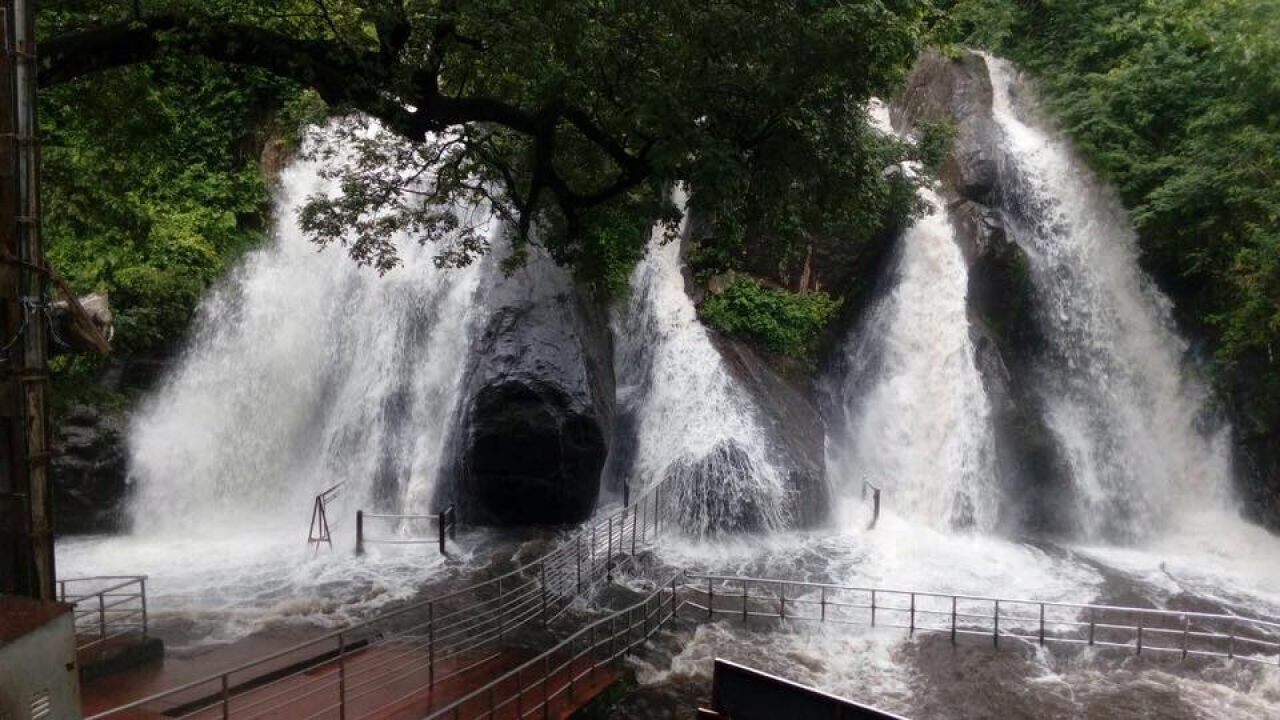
[682,574,1280,667]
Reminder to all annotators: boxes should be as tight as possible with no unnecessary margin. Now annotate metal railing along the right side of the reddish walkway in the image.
[426,574,680,720]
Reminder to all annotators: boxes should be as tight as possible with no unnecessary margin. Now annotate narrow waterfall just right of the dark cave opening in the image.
[614,191,787,534]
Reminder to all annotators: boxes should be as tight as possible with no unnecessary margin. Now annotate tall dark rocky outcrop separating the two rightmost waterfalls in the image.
[891,51,1071,533]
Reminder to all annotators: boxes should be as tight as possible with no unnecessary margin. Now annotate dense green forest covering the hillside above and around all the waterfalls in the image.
[40,0,1280,509]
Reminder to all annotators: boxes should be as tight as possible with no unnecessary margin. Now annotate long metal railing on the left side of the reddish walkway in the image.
[93,474,668,720]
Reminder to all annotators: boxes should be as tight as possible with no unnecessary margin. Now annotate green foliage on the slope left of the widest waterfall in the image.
[40,53,314,353]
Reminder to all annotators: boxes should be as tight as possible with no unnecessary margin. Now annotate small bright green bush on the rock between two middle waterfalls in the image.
[701,277,841,357]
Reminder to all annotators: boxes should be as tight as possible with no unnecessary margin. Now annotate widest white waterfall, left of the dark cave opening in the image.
[129,122,495,534]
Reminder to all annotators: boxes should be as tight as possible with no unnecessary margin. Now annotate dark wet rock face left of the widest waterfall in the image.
[49,405,128,534]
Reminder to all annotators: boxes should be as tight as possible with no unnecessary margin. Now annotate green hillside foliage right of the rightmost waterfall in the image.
[952,0,1280,421]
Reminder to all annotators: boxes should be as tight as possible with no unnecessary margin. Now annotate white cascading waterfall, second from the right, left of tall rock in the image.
[828,104,998,529]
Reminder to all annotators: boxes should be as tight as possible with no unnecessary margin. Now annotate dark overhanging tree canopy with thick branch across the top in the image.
[40,0,929,292]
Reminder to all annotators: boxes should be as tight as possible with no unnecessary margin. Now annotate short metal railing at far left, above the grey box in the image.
[58,575,147,651]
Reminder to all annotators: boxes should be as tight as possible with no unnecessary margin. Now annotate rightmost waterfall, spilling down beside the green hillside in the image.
[987,58,1231,538]
